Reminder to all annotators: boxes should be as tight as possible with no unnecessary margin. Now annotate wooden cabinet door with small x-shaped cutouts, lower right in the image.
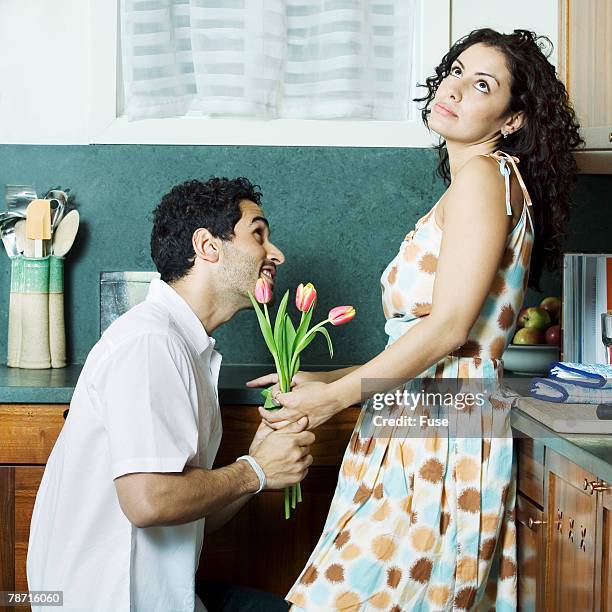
[546,448,597,612]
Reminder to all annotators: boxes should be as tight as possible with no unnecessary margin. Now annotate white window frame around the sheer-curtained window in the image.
[88,0,451,148]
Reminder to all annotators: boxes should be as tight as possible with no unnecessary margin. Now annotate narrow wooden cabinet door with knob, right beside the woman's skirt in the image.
[516,493,546,612]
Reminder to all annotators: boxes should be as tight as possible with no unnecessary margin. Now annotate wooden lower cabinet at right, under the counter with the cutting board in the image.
[515,437,612,612]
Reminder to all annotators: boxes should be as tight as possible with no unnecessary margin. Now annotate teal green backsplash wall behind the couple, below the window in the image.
[0,145,612,364]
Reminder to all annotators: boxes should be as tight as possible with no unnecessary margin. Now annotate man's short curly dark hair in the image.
[151,177,262,283]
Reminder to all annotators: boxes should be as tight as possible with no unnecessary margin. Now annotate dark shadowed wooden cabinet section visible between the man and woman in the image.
[197,406,359,596]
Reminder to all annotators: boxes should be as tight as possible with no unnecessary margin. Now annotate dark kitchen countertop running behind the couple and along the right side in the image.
[0,364,612,482]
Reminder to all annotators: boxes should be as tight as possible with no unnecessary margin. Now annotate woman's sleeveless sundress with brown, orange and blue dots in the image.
[287,151,534,612]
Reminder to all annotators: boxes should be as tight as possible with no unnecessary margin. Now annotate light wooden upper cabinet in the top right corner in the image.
[559,0,612,173]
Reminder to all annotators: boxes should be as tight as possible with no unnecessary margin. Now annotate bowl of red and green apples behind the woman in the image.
[502,297,561,376]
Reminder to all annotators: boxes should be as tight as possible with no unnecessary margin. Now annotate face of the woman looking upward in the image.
[428,43,510,144]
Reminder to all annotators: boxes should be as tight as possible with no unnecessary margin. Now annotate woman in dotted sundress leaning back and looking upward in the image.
[250,29,581,612]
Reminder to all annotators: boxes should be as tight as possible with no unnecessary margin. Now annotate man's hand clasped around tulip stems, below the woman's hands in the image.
[251,418,315,489]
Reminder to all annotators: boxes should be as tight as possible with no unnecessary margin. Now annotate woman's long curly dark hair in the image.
[414,28,584,291]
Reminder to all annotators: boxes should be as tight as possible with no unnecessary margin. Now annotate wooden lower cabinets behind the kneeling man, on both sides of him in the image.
[0,404,359,610]
